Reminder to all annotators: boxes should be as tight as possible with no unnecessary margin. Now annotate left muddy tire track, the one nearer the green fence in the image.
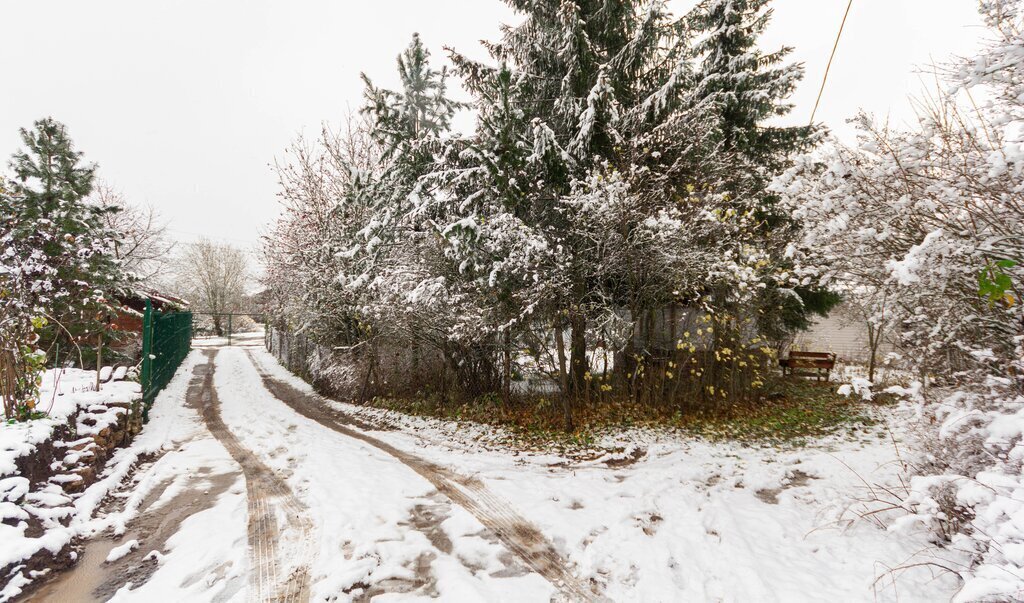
[187,349,312,603]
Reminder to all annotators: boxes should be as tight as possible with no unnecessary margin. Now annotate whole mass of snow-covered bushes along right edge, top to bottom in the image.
[773,0,1024,601]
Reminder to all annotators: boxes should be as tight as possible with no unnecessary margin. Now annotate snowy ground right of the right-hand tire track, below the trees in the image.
[249,348,965,601]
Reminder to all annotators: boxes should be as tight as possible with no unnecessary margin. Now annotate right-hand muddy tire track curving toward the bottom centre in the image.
[246,350,603,601]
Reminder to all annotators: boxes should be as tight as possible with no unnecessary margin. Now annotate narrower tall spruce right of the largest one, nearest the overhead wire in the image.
[687,0,839,339]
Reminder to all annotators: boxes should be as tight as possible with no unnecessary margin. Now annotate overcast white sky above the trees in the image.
[0,0,983,255]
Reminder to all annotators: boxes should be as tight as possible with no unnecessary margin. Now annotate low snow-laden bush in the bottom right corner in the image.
[869,377,1024,603]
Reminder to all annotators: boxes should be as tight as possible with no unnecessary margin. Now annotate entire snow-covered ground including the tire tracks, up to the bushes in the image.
[6,340,965,601]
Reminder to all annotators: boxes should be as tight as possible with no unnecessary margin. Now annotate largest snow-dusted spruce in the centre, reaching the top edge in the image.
[446,0,729,399]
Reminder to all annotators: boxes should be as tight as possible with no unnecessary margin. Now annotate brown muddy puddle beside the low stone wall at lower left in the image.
[22,470,239,603]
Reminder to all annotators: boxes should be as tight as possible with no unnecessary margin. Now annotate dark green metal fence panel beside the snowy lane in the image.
[141,300,193,421]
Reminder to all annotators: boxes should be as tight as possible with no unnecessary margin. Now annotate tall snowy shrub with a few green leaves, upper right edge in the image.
[773,1,1024,381]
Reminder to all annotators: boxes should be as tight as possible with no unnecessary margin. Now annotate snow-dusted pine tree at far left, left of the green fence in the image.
[8,118,125,362]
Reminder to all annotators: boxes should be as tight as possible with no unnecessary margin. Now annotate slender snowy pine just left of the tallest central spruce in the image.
[336,35,472,381]
